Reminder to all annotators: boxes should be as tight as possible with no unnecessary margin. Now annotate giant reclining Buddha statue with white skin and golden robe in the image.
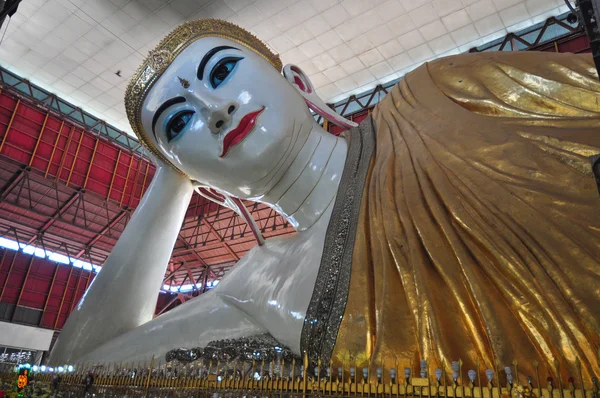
[50,20,600,380]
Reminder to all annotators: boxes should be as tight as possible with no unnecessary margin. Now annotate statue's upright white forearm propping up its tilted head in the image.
[50,165,193,364]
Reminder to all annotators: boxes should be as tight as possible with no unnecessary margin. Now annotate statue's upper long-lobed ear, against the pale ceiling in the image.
[283,64,358,128]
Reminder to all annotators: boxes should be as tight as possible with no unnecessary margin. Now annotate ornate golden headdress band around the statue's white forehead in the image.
[125,19,282,169]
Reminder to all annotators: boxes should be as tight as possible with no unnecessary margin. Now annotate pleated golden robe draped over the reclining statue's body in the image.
[310,52,600,383]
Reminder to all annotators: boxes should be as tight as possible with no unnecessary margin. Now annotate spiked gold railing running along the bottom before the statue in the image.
[0,352,600,398]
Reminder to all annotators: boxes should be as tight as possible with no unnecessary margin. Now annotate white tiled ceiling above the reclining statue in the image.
[0,0,566,136]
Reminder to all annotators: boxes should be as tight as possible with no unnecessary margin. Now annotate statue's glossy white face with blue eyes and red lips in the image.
[142,37,313,198]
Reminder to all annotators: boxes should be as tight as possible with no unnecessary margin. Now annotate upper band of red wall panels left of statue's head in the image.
[0,93,155,207]
